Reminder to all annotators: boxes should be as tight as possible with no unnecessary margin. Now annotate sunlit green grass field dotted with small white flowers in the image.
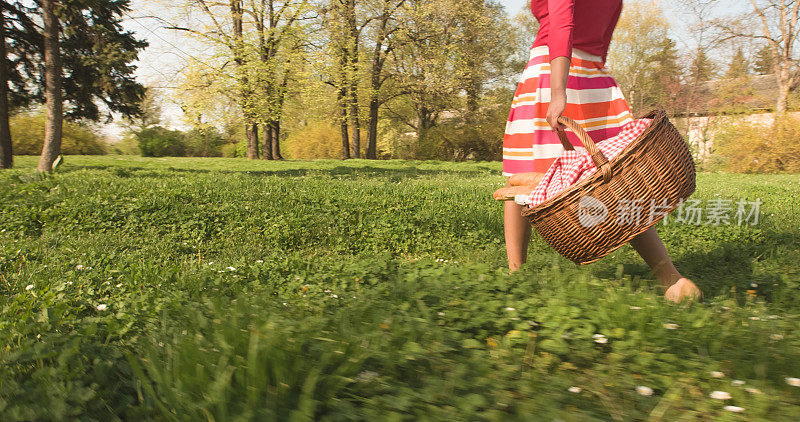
[0,156,800,421]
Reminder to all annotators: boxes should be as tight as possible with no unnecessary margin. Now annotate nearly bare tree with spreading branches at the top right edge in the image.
[715,0,800,113]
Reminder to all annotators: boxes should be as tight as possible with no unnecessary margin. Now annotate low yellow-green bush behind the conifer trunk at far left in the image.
[9,110,107,155]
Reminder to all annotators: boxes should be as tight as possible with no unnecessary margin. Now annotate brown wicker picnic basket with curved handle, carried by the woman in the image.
[522,110,695,264]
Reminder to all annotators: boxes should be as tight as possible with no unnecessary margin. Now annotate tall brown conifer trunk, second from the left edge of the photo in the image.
[36,0,63,172]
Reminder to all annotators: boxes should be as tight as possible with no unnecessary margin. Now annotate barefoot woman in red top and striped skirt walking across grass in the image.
[494,0,701,302]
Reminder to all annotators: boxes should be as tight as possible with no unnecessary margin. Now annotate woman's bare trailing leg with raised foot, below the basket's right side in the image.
[631,227,702,302]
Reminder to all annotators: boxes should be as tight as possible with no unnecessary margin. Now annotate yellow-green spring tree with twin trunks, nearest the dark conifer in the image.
[169,0,308,160]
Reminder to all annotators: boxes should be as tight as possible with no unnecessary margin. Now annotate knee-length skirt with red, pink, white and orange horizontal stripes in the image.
[503,46,633,176]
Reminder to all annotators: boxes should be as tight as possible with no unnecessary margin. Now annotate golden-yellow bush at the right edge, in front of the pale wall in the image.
[714,116,800,173]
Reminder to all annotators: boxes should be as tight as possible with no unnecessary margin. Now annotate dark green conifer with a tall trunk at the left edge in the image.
[0,0,147,171]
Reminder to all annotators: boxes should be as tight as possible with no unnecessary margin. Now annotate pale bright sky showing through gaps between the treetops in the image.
[111,0,748,138]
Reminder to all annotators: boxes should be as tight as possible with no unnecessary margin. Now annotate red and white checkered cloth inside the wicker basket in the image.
[514,119,652,207]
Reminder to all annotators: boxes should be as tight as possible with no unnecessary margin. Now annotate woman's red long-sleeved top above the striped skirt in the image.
[531,0,622,63]
